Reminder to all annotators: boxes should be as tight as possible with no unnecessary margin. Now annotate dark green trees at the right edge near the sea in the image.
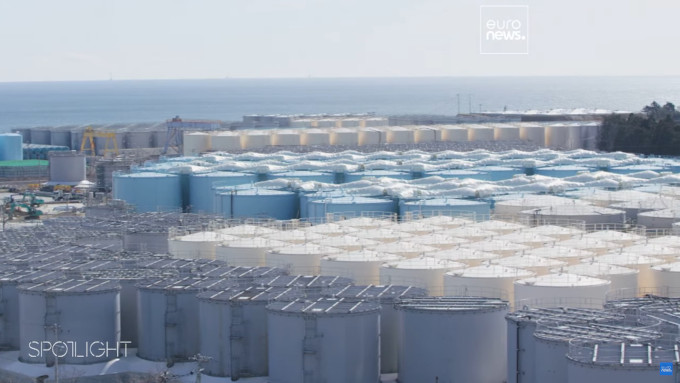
[598,102,680,156]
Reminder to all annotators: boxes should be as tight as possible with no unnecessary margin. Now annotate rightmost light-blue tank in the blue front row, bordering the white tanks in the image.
[399,198,491,219]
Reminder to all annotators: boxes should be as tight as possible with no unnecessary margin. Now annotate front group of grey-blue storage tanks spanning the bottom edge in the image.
[0,255,680,383]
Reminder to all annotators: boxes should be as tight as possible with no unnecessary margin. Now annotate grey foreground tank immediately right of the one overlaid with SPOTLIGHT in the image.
[137,277,235,362]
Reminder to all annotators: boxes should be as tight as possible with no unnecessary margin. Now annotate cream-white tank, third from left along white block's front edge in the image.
[265,243,342,275]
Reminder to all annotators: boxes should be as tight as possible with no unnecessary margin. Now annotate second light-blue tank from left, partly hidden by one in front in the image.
[189,172,255,213]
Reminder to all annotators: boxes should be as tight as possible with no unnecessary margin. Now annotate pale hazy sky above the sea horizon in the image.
[0,0,680,82]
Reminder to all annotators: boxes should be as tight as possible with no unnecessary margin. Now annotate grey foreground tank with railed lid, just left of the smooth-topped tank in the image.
[267,298,380,383]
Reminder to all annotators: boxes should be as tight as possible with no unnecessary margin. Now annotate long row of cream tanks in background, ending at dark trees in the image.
[183,122,599,155]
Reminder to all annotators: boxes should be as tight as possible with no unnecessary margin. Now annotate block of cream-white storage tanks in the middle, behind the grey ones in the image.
[168,216,680,307]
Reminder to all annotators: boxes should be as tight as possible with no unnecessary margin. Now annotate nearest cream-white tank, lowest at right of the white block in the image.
[515,273,611,308]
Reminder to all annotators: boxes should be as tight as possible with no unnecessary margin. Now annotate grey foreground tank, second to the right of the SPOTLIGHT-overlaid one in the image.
[198,287,290,380]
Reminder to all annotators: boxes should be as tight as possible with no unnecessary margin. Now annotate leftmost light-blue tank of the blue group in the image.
[113,172,182,212]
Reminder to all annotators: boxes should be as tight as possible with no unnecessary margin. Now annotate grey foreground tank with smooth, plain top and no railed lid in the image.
[396,297,508,383]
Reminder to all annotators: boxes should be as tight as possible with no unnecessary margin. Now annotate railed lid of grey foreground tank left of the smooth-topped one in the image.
[267,298,380,316]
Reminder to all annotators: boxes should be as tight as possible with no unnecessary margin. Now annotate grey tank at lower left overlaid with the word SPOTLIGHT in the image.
[19,279,125,365]
